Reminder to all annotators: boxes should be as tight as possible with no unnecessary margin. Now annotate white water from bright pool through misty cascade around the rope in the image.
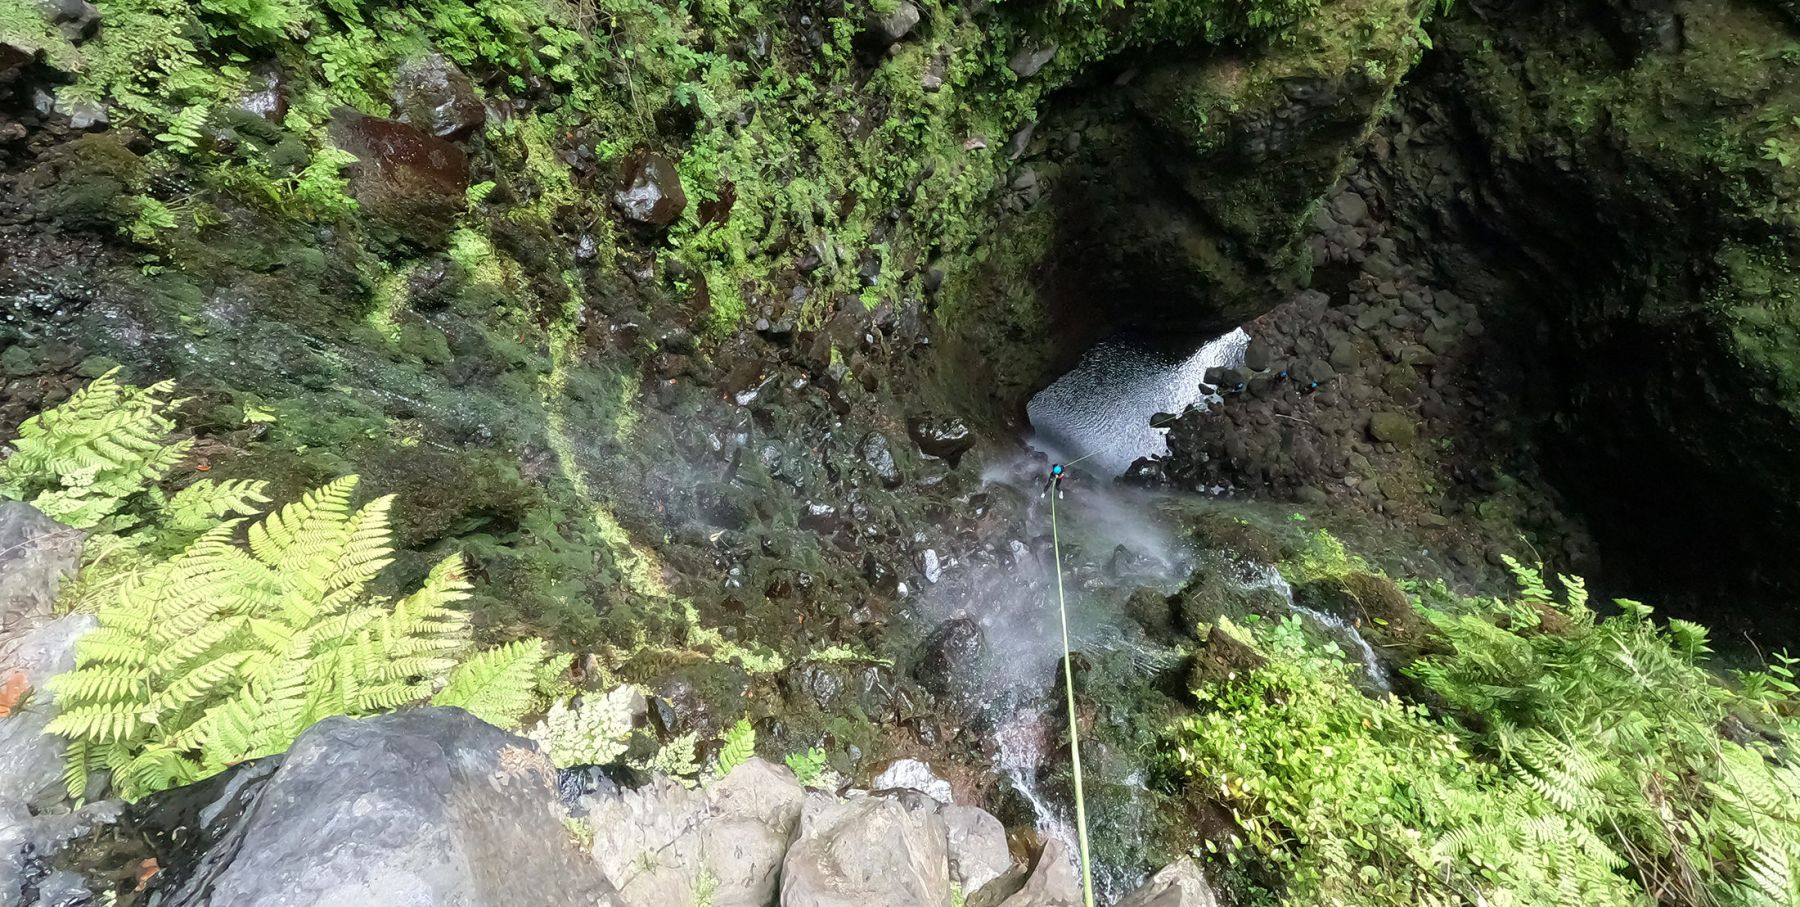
[922,329,1390,902]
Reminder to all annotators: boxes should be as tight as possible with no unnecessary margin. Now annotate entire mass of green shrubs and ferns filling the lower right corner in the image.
[1166,545,1800,905]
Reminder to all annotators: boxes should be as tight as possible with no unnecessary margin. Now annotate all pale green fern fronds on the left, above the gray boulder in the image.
[0,373,554,799]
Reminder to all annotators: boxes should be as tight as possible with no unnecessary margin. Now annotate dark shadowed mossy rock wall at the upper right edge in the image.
[1375,2,1800,622]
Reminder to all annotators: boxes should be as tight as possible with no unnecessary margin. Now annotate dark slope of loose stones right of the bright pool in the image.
[1139,169,1598,581]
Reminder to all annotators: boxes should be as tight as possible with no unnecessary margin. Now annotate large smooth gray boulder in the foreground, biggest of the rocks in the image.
[164,709,619,907]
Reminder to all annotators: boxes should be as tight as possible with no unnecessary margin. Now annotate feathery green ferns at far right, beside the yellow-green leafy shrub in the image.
[1411,567,1800,903]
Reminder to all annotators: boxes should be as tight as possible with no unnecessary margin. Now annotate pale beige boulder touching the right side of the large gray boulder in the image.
[581,759,805,907]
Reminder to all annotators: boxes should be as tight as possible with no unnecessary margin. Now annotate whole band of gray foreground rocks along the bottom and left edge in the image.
[0,504,1217,907]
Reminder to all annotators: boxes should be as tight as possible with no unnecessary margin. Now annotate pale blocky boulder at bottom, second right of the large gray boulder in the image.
[781,792,950,907]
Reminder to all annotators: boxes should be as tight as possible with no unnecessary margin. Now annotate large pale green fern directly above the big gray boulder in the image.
[49,477,545,799]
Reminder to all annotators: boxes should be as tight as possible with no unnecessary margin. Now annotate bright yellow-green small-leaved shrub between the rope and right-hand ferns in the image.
[1168,619,1638,905]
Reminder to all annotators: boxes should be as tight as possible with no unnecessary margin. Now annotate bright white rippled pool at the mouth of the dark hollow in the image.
[1026,328,1249,475]
